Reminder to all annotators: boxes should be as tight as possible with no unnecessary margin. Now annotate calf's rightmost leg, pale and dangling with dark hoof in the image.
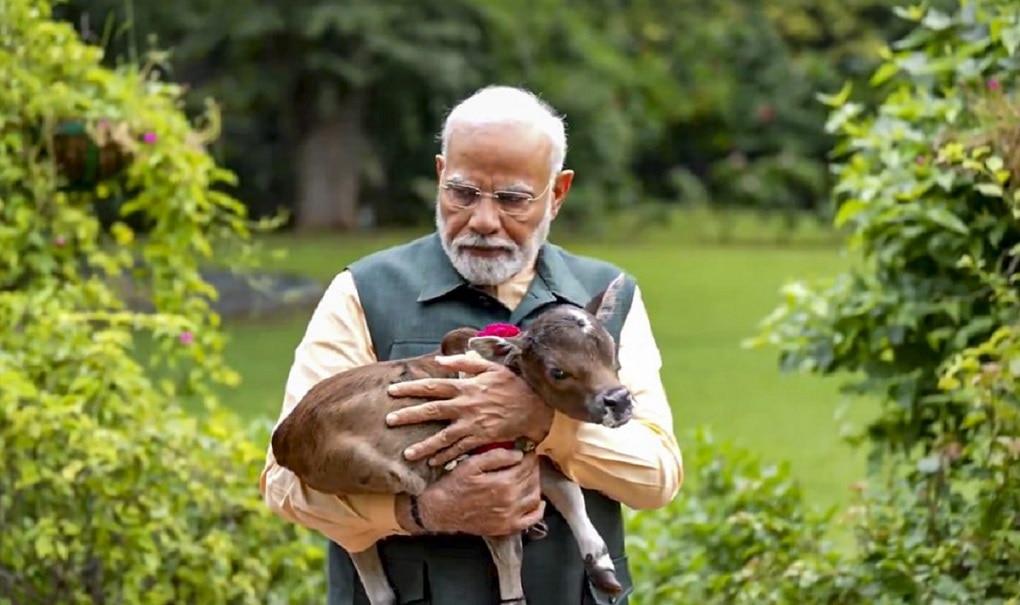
[539,456,623,595]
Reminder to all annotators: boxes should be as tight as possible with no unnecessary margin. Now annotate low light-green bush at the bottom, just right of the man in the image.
[627,430,836,605]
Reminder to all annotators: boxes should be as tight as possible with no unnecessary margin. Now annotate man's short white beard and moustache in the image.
[436,199,553,286]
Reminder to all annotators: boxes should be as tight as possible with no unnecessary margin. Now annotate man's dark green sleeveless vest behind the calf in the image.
[328,234,633,605]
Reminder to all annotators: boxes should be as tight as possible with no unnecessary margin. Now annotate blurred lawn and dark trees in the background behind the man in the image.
[47,0,930,514]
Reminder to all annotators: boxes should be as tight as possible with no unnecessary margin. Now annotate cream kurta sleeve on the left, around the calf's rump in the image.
[259,271,406,552]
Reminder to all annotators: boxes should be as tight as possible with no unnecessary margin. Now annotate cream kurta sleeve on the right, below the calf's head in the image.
[538,288,683,509]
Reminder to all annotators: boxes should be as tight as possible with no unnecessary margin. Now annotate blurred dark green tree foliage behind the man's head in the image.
[61,0,909,233]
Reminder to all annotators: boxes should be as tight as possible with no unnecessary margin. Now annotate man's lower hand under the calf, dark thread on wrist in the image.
[397,449,546,537]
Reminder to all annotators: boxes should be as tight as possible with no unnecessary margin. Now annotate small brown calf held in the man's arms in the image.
[272,275,633,605]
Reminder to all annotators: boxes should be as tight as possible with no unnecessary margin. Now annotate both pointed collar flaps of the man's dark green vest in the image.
[418,233,589,307]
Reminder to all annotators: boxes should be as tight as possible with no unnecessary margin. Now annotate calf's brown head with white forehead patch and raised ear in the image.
[452,274,633,427]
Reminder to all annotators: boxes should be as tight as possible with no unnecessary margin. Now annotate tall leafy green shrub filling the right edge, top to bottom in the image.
[742,0,1020,603]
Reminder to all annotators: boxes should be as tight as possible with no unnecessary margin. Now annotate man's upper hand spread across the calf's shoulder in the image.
[387,355,553,466]
